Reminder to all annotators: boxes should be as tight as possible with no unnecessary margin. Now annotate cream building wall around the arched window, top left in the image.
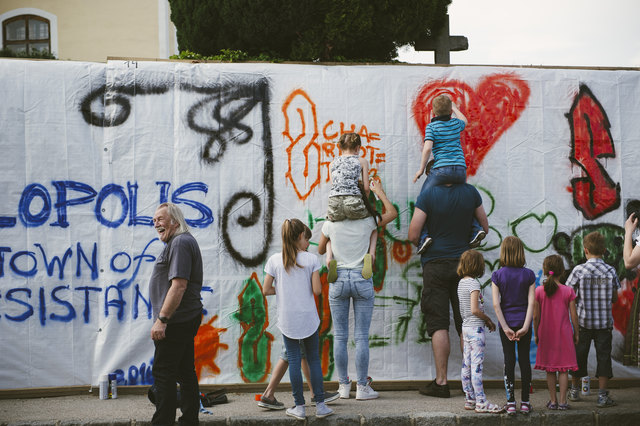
[0,0,177,62]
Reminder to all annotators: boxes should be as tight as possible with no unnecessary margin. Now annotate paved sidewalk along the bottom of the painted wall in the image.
[0,387,640,426]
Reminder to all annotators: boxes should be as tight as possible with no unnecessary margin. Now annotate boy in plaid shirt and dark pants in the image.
[566,231,620,407]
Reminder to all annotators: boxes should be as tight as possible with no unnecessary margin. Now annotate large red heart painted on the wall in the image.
[413,74,531,176]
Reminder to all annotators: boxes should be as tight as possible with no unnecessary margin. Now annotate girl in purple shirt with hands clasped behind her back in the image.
[491,236,536,415]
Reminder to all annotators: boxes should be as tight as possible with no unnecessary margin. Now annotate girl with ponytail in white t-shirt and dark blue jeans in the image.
[262,219,333,420]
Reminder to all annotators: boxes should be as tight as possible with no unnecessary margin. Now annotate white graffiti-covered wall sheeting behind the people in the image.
[0,60,640,389]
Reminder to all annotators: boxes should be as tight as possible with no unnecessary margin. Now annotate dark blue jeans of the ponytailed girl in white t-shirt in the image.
[282,330,324,405]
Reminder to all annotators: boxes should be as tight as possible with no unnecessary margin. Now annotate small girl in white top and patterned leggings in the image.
[458,250,503,413]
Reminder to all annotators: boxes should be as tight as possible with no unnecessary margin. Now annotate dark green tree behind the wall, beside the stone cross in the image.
[169,0,451,62]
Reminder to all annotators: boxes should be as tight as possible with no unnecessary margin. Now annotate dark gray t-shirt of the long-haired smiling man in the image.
[149,232,202,323]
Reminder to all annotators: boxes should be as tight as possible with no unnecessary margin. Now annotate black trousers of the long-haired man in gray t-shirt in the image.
[151,315,201,425]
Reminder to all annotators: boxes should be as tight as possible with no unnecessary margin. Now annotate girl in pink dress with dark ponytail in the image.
[533,254,578,410]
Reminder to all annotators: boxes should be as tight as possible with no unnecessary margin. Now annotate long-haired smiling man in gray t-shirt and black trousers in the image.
[149,203,202,425]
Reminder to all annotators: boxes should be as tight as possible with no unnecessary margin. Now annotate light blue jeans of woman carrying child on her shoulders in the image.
[329,269,374,386]
